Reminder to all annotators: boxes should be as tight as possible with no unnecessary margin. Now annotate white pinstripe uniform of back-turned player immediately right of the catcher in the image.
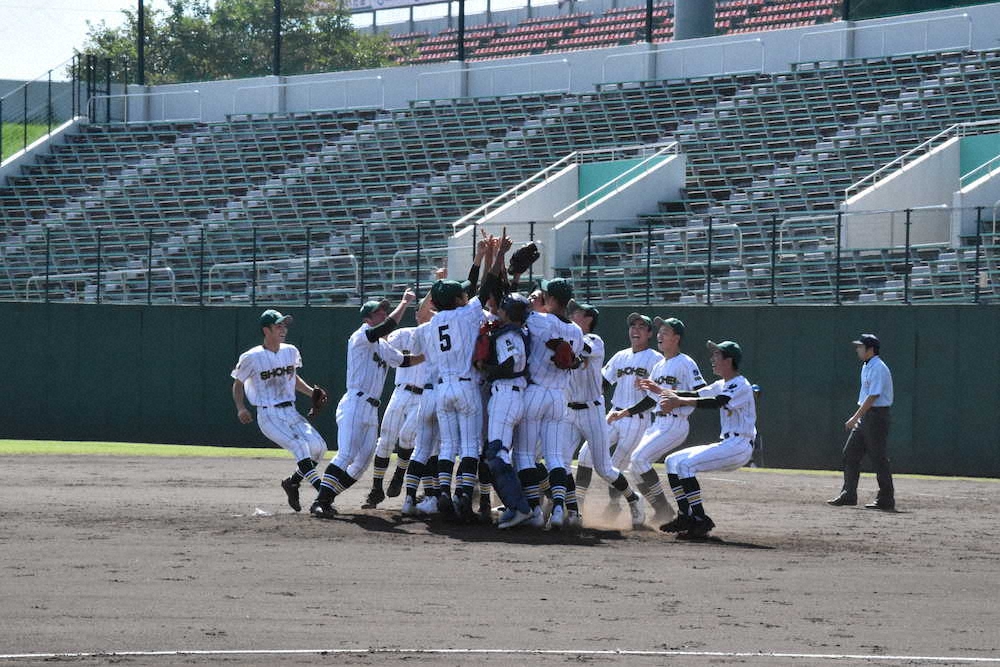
[514,311,583,471]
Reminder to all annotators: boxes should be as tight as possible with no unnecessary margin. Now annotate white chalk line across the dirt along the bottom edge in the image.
[0,647,1000,664]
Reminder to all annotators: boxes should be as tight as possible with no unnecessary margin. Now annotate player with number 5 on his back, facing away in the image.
[426,280,484,520]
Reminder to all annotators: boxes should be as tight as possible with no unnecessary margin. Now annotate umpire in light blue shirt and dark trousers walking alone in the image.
[827,334,896,512]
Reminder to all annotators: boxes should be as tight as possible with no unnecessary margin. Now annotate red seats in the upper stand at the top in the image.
[392,0,842,64]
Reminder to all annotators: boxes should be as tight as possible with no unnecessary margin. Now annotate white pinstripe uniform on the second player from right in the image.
[630,353,705,475]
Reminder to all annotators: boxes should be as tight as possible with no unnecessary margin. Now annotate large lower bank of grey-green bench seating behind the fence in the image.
[0,47,1000,303]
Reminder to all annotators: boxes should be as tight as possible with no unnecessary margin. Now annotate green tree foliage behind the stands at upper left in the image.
[83,0,394,85]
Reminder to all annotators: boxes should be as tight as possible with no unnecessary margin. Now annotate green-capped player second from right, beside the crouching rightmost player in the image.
[629,317,705,525]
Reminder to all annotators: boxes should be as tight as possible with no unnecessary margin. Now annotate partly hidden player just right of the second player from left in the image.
[362,299,433,509]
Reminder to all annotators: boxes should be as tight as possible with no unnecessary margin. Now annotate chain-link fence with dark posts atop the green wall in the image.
[7,207,1000,306]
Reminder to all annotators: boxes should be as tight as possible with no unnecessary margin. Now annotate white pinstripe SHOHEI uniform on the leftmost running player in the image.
[230,343,326,463]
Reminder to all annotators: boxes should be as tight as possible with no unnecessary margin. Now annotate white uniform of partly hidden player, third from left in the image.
[375,327,426,458]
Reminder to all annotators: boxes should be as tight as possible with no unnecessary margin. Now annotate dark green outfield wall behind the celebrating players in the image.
[0,303,1000,477]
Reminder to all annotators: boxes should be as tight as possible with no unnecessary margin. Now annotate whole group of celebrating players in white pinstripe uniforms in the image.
[232,233,756,539]
